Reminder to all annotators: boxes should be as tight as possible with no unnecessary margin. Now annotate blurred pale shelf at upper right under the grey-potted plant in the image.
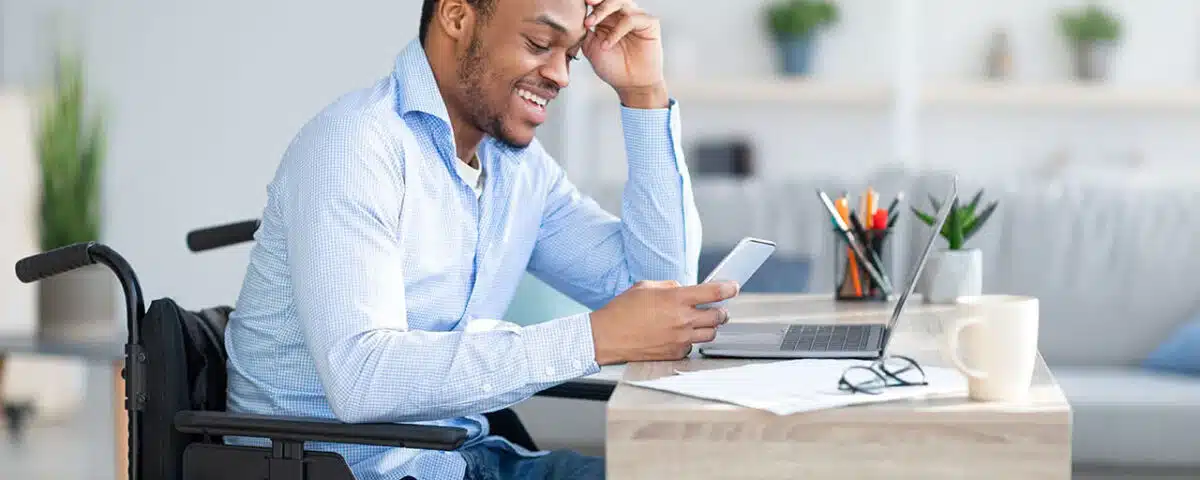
[923,83,1200,110]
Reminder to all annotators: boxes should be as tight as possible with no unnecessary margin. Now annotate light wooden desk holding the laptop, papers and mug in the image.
[606,295,1072,480]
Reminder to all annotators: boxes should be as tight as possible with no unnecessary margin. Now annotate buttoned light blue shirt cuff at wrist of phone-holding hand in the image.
[523,313,600,384]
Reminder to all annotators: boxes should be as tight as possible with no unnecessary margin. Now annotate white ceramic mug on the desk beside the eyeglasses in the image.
[946,295,1038,402]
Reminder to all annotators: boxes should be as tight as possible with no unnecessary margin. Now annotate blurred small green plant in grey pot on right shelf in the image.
[1058,5,1122,82]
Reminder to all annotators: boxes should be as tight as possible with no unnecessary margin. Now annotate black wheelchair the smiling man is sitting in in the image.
[16,220,613,480]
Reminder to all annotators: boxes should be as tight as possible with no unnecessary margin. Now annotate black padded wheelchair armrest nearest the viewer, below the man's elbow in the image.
[175,410,467,450]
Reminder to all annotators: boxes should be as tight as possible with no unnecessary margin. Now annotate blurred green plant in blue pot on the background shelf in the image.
[767,0,839,76]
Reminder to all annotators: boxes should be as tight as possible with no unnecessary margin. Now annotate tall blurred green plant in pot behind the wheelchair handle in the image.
[37,45,119,341]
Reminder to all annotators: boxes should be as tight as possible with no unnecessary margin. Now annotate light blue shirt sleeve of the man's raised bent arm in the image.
[529,100,702,308]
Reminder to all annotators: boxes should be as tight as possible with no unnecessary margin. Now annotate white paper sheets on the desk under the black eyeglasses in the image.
[626,359,967,415]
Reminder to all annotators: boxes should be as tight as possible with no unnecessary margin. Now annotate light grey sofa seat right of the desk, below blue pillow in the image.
[1052,367,1200,467]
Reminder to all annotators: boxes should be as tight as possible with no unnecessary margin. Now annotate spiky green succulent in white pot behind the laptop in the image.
[912,190,998,304]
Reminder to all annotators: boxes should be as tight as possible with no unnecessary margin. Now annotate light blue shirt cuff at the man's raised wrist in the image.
[620,98,685,174]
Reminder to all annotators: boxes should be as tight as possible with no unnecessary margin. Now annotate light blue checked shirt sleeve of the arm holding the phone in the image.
[278,120,599,422]
